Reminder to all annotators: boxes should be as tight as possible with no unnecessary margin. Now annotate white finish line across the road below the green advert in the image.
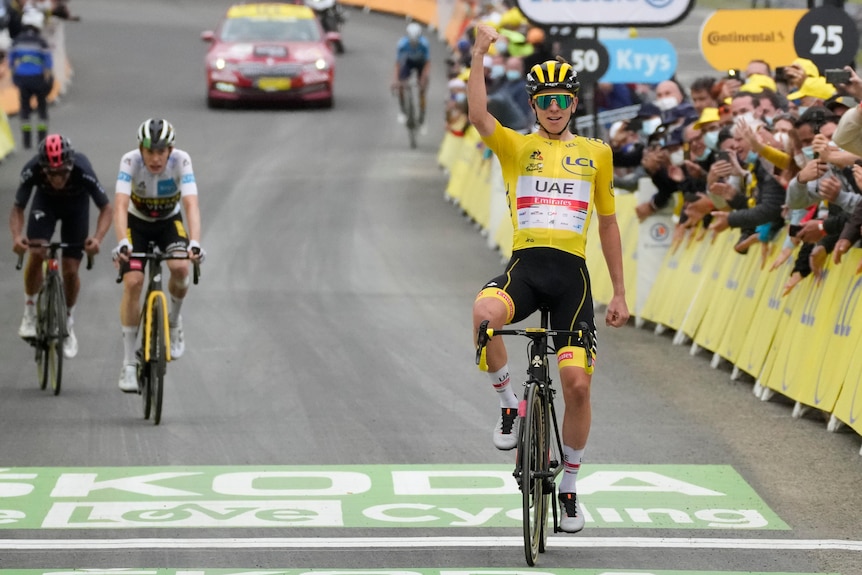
[0,537,862,552]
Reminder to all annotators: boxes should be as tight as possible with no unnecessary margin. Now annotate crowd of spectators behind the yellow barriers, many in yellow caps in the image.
[446,0,862,293]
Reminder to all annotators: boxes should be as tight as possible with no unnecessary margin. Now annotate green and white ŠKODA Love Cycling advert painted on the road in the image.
[0,465,788,531]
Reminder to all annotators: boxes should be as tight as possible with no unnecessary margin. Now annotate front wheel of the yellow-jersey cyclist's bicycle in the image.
[519,384,548,566]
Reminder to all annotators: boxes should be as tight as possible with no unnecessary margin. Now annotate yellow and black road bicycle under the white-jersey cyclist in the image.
[117,242,200,425]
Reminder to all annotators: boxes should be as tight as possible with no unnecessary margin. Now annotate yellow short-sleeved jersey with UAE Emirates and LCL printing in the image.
[482,122,615,259]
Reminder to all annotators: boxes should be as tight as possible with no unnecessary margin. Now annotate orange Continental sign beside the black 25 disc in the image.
[700,10,808,70]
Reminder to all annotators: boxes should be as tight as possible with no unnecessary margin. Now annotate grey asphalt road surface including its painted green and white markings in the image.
[0,0,862,575]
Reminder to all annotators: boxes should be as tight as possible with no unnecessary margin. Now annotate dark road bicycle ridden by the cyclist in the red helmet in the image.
[15,242,93,395]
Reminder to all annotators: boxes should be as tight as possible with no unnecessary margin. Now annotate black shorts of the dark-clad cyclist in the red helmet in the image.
[27,189,90,260]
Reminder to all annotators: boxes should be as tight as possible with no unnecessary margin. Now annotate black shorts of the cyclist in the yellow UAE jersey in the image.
[479,248,596,355]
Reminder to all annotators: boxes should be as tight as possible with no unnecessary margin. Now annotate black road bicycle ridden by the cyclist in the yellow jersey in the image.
[476,308,595,566]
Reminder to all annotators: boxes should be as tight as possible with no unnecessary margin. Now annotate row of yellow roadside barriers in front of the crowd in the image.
[438,134,862,450]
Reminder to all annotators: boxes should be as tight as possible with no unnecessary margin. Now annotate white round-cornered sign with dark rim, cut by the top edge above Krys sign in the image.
[518,0,694,27]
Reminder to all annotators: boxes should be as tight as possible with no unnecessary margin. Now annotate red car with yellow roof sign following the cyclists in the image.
[201,3,340,108]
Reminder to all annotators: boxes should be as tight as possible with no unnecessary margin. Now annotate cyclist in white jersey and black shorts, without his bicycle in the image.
[114,119,206,393]
